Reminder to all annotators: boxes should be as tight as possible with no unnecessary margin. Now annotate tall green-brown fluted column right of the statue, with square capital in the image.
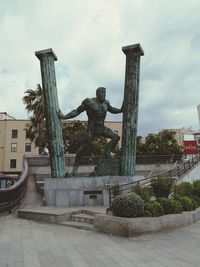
[121,44,144,175]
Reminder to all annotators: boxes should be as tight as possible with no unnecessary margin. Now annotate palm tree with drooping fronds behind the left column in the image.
[22,84,47,153]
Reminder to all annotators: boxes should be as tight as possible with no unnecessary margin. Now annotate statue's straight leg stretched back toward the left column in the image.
[71,133,92,176]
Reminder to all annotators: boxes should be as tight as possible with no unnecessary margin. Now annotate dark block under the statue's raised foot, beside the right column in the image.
[95,158,120,176]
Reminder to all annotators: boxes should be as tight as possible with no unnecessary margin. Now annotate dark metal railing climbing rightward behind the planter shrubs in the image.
[107,155,200,207]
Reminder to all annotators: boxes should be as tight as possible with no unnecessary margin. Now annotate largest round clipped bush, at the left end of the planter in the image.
[111,192,144,218]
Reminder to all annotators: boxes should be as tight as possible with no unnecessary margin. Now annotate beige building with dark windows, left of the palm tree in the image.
[0,112,38,174]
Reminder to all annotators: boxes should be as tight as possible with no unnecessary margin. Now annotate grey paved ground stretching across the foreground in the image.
[0,214,200,267]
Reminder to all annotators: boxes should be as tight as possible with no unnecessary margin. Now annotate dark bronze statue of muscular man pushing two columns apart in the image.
[58,87,123,176]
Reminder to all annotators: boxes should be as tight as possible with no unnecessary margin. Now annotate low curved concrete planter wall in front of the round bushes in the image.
[94,208,200,237]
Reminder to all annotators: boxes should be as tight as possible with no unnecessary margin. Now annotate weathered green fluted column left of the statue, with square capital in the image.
[35,49,66,178]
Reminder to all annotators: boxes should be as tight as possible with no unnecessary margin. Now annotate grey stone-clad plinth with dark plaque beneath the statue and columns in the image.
[44,176,144,207]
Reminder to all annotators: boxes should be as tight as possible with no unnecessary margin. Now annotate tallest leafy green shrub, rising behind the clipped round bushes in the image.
[151,176,174,198]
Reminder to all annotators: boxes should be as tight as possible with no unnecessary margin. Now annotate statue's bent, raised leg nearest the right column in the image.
[101,127,120,158]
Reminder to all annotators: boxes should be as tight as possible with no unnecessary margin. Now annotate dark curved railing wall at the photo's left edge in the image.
[0,159,28,213]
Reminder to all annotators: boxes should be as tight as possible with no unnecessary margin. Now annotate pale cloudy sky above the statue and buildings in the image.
[0,0,200,136]
